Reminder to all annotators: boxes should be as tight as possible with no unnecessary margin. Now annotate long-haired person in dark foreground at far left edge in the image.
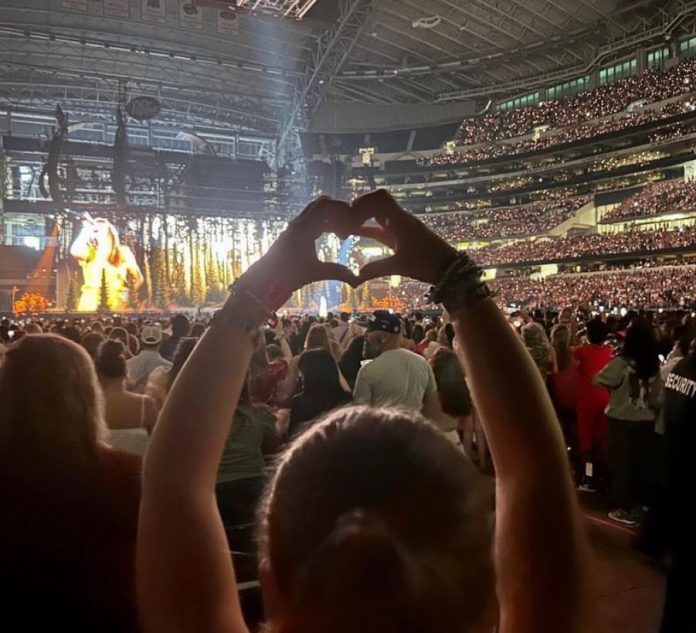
[0,334,140,633]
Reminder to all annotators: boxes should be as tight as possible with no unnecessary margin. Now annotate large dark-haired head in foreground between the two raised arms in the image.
[259,407,494,633]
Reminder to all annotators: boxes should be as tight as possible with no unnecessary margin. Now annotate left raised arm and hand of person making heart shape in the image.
[137,199,356,633]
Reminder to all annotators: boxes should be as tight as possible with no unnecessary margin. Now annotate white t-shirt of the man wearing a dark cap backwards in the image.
[353,349,437,411]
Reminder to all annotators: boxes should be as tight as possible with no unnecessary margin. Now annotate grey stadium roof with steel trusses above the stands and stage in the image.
[0,0,696,141]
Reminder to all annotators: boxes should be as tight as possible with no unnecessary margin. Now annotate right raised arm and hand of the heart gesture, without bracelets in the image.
[354,192,591,633]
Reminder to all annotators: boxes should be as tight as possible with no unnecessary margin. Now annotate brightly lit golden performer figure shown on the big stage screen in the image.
[70,214,143,312]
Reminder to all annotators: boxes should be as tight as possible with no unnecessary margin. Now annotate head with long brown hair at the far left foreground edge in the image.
[0,334,103,472]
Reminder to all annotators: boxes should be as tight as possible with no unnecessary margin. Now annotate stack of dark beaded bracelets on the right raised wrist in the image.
[426,254,493,313]
